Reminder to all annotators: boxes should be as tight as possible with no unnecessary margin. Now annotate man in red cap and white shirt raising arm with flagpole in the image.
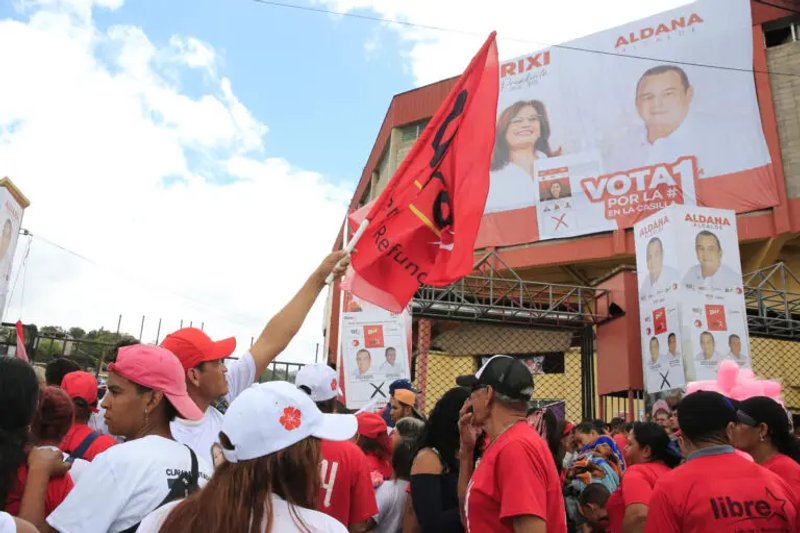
[161,251,348,462]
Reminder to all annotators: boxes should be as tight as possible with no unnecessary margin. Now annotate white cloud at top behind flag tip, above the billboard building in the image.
[317,0,689,85]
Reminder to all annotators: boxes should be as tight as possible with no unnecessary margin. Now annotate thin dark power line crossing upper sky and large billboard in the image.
[252,0,800,78]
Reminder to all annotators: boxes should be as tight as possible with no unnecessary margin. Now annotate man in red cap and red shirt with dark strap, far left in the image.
[60,370,117,461]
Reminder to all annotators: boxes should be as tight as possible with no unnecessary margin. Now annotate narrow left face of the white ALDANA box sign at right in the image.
[634,210,686,394]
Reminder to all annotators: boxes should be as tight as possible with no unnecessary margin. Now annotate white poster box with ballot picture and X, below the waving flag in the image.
[339,291,411,409]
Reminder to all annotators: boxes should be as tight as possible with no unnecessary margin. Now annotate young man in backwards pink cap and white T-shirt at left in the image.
[25,344,212,533]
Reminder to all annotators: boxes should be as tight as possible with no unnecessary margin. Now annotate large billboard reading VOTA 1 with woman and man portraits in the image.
[476,0,778,247]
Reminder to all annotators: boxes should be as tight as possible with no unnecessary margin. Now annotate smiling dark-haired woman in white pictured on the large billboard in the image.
[485,100,560,213]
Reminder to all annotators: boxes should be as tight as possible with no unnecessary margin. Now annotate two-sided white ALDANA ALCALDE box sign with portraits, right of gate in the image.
[634,206,751,386]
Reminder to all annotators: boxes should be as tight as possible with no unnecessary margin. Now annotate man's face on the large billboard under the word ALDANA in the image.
[636,70,692,142]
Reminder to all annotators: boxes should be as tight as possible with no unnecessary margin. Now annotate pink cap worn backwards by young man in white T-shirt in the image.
[108,344,203,420]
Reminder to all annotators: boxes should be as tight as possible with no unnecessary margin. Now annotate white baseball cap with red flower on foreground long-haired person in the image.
[222,381,358,463]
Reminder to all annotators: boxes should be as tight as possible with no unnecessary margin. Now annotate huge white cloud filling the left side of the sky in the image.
[0,0,350,360]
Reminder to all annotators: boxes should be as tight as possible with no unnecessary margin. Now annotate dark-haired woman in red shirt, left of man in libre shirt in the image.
[607,422,682,533]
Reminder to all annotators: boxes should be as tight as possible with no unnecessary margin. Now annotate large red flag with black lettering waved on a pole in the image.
[351,33,498,313]
